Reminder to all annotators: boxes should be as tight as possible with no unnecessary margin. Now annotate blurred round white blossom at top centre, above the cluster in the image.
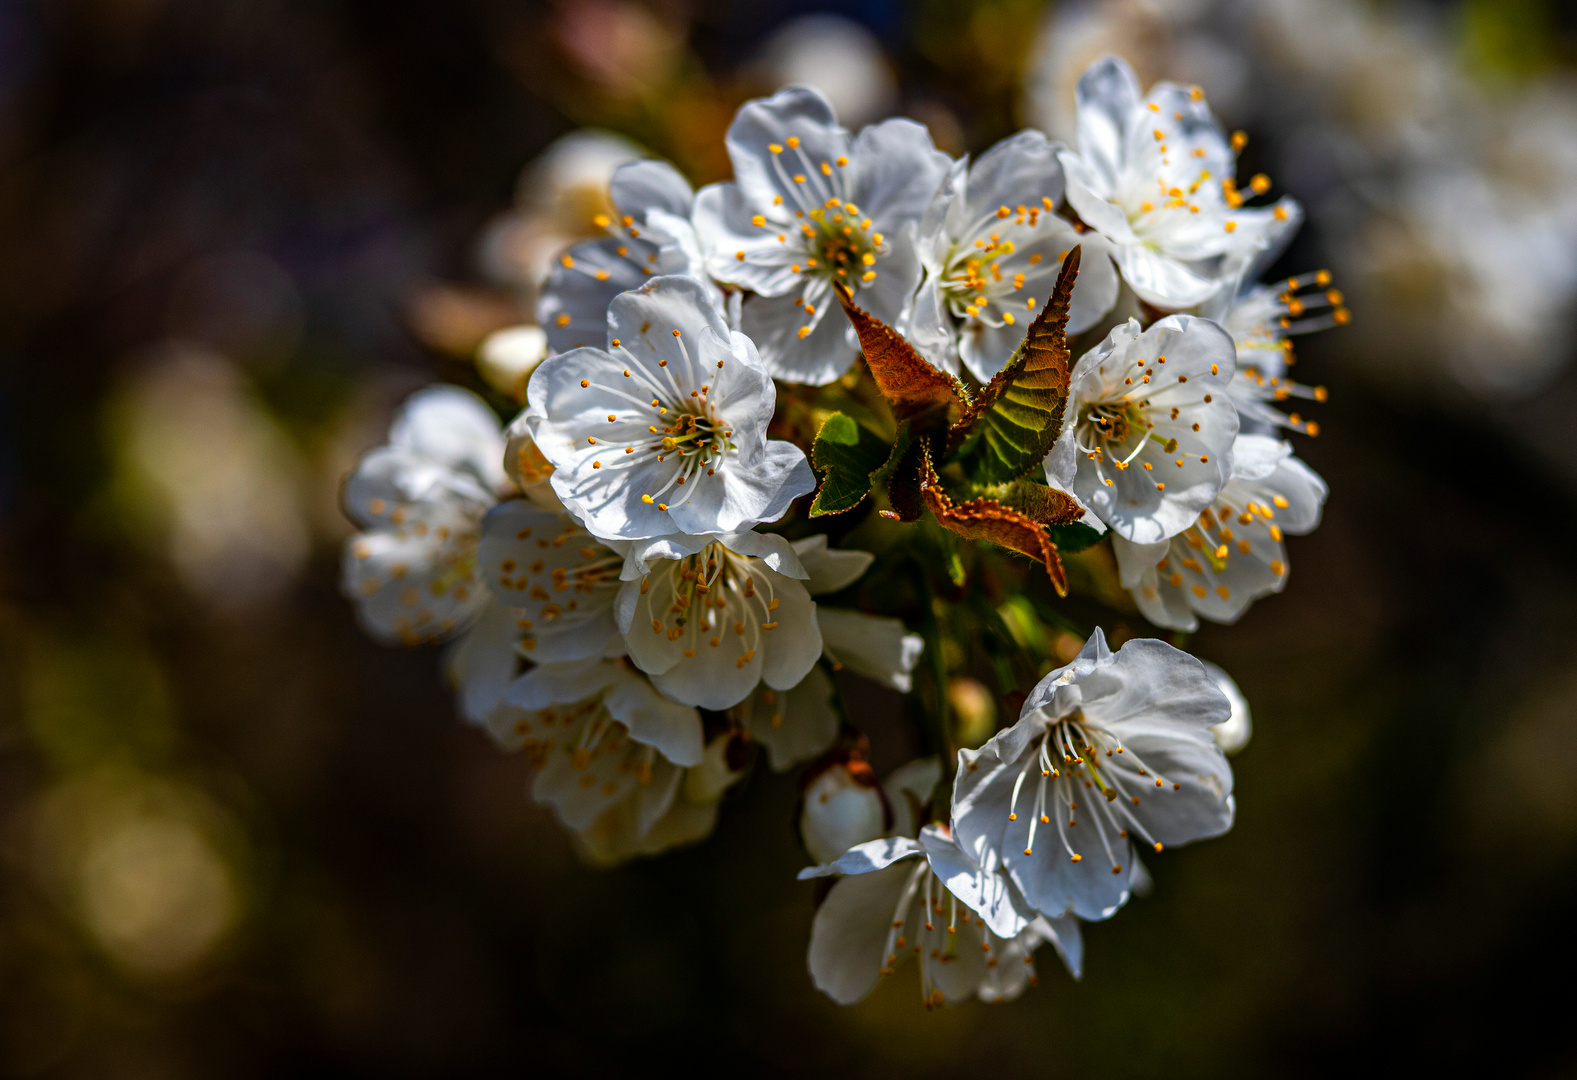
[755,14,897,126]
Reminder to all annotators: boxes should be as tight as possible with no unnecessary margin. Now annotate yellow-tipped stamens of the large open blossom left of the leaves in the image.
[580,330,735,511]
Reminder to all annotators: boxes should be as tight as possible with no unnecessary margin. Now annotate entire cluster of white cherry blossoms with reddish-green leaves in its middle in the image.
[345,57,1347,1006]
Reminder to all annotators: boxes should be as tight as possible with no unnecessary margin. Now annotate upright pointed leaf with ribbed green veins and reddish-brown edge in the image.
[948,248,1080,484]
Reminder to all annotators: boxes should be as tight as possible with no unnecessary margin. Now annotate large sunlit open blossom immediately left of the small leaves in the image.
[527,277,815,539]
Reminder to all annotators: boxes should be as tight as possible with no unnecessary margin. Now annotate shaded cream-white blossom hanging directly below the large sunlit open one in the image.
[615,533,822,709]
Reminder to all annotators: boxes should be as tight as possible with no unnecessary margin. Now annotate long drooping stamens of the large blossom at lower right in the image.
[1008,709,1183,873]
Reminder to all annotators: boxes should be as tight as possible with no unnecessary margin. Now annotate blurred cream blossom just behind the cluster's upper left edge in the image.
[479,128,645,295]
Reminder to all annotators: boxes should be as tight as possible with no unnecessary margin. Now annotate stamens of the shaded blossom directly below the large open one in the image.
[639,544,779,668]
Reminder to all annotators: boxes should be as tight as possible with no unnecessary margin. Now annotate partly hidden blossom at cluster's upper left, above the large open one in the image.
[536,159,722,353]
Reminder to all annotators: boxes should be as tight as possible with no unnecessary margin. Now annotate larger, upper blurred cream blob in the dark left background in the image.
[112,345,309,609]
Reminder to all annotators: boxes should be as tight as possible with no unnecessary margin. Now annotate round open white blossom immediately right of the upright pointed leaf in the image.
[1046,315,1238,544]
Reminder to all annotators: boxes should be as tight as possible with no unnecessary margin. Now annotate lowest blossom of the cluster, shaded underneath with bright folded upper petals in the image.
[800,825,1083,1009]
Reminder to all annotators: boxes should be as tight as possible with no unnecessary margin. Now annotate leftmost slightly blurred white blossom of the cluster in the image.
[344,386,509,645]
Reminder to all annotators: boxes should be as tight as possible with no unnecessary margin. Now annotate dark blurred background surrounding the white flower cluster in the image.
[0,0,1577,1080]
